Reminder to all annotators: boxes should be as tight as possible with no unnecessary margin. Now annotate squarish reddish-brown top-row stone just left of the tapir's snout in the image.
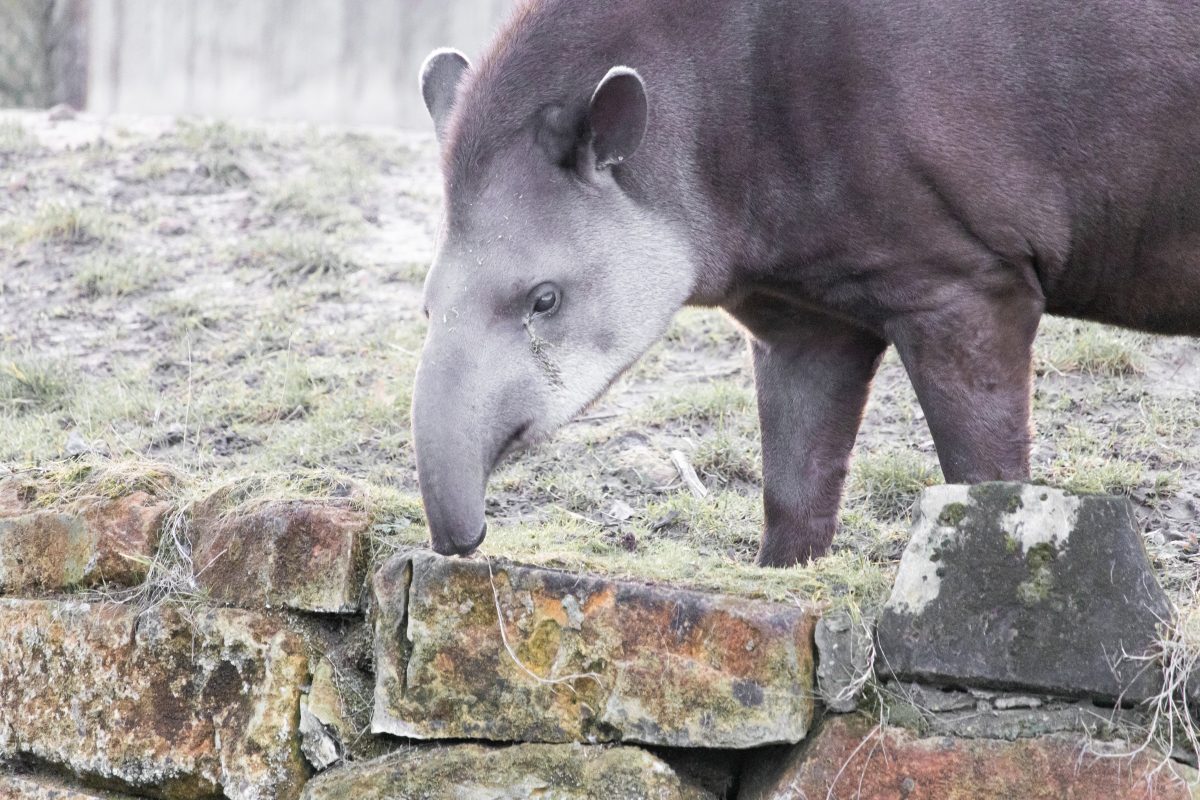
[191,500,368,614]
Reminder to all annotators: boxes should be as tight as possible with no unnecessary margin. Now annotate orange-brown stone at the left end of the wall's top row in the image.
[0,483,168,595]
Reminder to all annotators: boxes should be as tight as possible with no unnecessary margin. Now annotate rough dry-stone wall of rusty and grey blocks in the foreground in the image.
[0,480,1198,800]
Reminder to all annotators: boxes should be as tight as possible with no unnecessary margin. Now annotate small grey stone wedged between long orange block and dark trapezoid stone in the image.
[815,610,875,714]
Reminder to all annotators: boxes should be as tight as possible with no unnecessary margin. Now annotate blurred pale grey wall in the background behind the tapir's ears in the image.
[88,0,514,130]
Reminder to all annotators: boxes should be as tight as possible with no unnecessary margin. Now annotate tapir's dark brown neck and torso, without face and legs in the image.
[448,0,1200,332]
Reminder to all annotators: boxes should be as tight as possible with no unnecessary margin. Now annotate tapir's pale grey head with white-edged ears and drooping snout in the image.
[413,50,692,554]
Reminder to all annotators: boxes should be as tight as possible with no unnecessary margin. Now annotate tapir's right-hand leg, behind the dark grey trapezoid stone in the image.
[886,285,1043,483]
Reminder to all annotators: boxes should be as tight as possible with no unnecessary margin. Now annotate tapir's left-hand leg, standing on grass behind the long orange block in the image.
[733,297,887,566]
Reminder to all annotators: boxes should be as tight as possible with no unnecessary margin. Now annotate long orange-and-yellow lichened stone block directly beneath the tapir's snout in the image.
[372,552,816,748]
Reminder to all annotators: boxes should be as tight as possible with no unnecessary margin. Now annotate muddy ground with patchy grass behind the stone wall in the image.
[0,113,1200,618]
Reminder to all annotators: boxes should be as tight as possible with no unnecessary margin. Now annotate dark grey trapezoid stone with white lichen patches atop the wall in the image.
[876,483,1171,703]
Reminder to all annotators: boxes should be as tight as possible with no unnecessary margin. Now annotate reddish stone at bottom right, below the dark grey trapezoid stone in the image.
[738,716,1200,800]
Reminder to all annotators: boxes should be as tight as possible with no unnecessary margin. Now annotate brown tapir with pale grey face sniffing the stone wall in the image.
[413,0,1200,566]
